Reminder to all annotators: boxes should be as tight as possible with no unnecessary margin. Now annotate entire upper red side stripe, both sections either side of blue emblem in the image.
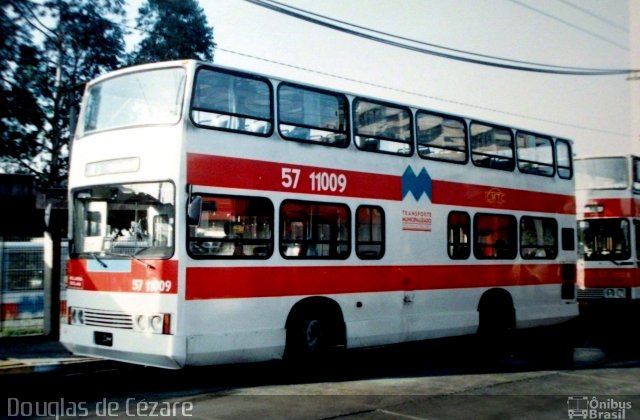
[187,153,576,214]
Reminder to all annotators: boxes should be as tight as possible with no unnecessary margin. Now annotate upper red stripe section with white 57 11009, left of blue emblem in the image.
[187,153,402,201]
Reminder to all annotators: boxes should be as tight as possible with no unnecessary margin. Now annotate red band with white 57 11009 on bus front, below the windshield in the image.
[67,259,178,294]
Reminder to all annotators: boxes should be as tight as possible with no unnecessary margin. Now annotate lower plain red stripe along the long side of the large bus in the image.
[186,264,562,300]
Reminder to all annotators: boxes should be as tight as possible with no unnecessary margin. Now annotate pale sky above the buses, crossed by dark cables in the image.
[130,0,640,157]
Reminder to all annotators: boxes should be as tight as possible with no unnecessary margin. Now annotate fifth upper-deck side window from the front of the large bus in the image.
[471,122,515,171]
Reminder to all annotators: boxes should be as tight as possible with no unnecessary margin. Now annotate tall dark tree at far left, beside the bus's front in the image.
[0,0,124,187]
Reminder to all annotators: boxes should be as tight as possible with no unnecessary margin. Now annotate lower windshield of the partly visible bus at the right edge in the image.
[578,219,631,261]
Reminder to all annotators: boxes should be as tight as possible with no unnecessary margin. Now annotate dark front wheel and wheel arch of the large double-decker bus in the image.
[284,296,346,359]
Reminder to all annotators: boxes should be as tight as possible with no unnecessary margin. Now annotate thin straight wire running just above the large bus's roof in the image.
[216,47,628,137]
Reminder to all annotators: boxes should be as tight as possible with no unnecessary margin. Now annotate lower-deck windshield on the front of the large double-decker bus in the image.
[73,182,175,258]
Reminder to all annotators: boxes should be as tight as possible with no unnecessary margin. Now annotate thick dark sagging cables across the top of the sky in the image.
[245,0,635,76]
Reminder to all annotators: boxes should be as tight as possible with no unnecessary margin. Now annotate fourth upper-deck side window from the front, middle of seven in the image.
[416,111,467,163]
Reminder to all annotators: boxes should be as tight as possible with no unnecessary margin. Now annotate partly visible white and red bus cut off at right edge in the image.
[576,155,640,304]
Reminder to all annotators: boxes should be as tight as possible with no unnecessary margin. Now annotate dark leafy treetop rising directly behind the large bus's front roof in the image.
[129,0,215,64]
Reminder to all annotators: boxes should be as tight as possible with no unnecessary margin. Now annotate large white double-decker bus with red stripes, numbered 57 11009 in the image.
[61,60,578,368]
